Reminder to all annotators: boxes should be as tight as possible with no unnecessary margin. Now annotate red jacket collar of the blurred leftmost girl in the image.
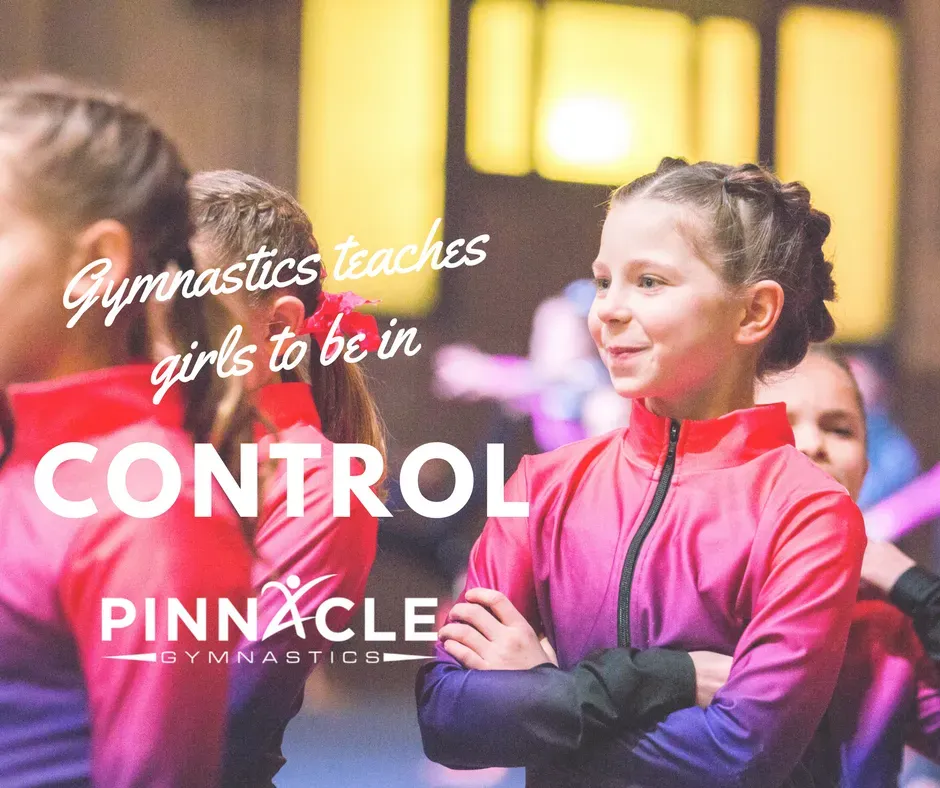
[6,364,183,458]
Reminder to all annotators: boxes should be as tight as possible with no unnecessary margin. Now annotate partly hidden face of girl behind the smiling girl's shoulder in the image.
[756,354,868,500]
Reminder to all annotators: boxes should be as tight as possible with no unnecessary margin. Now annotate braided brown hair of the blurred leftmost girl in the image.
[0,77,252,529]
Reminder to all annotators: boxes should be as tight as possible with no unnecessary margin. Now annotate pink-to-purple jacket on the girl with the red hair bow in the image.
[224,383,378,786]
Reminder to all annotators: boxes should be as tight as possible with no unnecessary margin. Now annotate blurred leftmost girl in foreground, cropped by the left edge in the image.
[0,80,250,788]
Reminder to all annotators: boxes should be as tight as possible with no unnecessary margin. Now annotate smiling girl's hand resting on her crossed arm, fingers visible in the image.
[438,588,553,670]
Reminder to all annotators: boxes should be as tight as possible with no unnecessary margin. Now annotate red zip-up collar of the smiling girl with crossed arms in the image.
[624,400,793,473]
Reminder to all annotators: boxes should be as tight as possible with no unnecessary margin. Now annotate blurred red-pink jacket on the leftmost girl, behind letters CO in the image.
[0,365,251,788]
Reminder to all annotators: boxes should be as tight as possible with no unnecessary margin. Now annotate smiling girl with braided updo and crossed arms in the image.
[417,160,865,788]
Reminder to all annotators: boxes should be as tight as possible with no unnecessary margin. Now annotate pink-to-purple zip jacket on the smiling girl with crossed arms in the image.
[417,402,865,788]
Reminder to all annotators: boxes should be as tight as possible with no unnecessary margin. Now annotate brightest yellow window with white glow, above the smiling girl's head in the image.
[535,0,695,184]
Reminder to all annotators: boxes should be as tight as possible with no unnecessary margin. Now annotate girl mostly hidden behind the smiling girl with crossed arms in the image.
[757,349,940,788]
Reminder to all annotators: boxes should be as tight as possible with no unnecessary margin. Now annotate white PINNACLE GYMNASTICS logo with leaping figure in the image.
[101,574,437,664]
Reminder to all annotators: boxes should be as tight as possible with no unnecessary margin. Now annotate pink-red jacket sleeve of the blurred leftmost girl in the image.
[59,499,250,788]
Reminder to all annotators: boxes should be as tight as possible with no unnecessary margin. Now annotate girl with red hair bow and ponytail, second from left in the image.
[190,171,385,786]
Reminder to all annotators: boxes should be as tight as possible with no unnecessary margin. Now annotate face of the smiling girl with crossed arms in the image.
[588,198,749,418]
